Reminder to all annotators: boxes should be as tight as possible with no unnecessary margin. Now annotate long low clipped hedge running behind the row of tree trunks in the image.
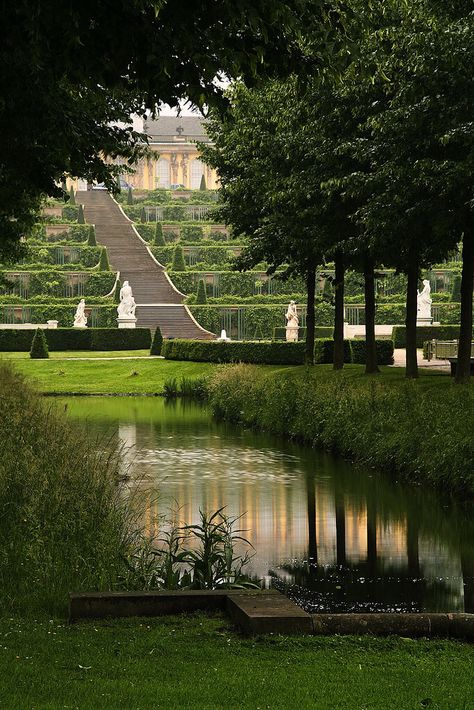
[161,338,393,365]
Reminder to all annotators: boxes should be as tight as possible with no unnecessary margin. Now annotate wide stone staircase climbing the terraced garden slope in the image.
[77,190,214,340]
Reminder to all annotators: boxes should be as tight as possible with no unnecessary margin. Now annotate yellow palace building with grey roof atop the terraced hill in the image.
[125,116,218,190]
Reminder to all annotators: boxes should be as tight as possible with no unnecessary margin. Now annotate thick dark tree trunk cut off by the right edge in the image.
[456,232,474,384]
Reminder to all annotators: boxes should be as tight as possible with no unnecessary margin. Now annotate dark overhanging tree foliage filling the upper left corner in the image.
[0,0,331,262]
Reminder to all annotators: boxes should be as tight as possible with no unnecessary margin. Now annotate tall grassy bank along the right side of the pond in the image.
[211,365,474,495]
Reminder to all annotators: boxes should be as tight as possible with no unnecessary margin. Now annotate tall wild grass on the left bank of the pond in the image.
[0,364,139,613]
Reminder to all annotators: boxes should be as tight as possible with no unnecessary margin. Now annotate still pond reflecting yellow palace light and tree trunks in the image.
[58,397,474,612]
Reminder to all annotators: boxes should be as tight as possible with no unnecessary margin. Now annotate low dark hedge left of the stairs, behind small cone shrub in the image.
[0,328,151,352]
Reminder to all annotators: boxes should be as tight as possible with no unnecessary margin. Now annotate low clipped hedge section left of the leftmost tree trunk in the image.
[161,338,305,365]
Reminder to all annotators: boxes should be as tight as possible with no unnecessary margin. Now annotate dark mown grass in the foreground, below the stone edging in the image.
[0,615,474,710]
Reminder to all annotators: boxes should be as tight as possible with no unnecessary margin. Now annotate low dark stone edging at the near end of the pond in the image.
[69,590,474,642]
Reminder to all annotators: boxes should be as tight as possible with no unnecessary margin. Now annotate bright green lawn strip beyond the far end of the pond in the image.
[6,358,216,394]
